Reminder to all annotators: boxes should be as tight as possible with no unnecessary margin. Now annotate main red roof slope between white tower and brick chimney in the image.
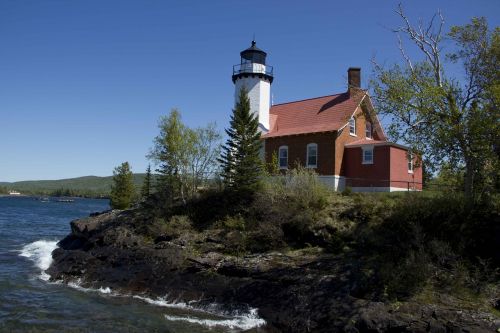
[263,93,362,138]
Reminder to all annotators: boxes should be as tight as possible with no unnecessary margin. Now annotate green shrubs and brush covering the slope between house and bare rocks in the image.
[137,167,500,301]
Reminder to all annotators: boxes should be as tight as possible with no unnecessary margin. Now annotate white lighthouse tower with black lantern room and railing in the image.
[233,41,273,133]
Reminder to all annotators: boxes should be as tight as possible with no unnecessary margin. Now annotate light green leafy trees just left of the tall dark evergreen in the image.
[148,109,221,202]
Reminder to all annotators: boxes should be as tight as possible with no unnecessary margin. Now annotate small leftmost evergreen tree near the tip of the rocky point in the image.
[110,162,134,209]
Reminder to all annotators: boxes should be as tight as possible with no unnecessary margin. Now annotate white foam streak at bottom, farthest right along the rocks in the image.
[165,309,266,330]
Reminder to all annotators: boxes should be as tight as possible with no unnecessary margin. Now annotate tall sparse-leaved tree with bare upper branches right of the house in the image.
[371,6,500,197]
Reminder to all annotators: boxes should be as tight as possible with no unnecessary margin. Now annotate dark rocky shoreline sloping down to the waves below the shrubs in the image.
[47,211,500,332]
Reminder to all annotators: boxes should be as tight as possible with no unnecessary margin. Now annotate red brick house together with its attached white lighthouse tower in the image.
[233,42,422,191]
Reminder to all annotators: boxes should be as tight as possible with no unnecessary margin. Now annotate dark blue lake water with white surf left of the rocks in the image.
[0,197,264,333]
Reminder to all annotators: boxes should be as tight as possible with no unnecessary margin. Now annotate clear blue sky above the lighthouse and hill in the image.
[0,0,500,181]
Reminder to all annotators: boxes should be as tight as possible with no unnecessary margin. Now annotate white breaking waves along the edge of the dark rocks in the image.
[19,240,266,330]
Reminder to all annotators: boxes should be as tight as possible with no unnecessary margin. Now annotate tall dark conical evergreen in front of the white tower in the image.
[219,88,262,191]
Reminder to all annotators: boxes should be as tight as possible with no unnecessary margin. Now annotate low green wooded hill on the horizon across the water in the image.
[0,173,145,196]
